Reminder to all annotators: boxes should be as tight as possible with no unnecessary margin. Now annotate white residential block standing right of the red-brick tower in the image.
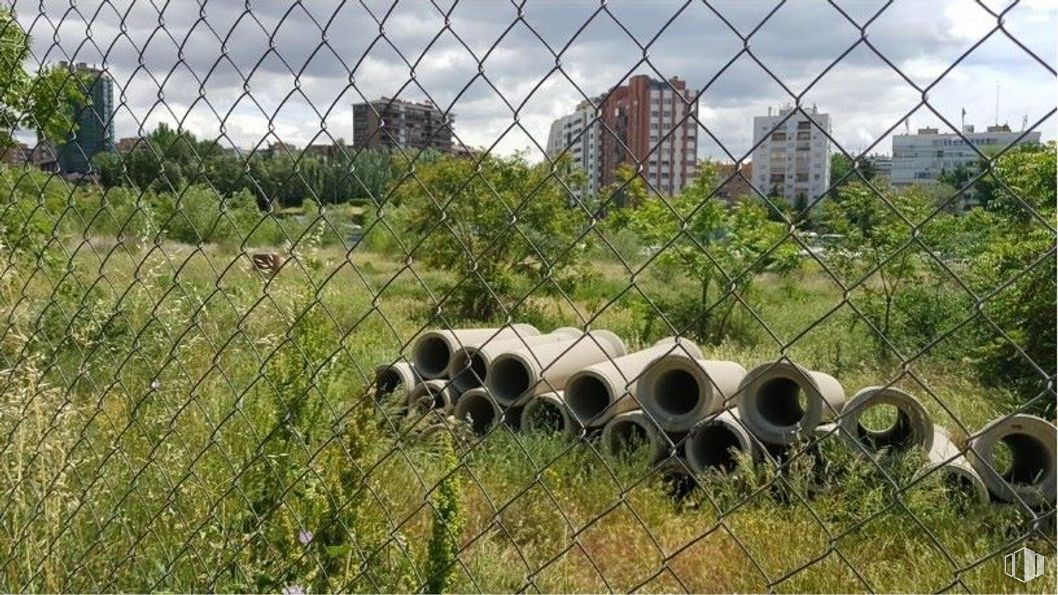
[753,106,831,205]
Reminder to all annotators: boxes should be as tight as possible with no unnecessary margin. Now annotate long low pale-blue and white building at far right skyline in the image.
[892,124,1040,186]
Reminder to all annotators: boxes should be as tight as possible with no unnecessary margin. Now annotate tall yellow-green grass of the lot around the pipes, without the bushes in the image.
[0,232,1054,591]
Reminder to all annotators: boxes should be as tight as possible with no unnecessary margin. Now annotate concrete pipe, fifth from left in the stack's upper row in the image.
[636,350,746,432]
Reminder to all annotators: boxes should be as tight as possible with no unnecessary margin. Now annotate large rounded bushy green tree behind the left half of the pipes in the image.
[395,151,587,320]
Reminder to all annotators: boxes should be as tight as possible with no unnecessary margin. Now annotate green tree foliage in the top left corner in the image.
[0,6,89,149]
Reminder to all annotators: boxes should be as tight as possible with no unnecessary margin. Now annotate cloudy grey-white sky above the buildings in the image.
[15,0,1058,159]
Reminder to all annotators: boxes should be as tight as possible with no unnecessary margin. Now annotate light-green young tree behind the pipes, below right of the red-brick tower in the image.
[628,161,798,342]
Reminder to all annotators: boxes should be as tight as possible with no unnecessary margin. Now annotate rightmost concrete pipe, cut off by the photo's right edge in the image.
[967,414,1058,506]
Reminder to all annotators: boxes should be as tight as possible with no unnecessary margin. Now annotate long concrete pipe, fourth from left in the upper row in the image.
[566,338,701,428]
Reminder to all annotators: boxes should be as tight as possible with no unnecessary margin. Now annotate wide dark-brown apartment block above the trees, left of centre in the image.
[352,97,455,152]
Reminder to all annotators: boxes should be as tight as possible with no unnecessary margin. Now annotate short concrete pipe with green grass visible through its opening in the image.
[838,386,933,454]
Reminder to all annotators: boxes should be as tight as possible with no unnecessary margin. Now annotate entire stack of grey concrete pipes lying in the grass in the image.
[376,324,1058,507]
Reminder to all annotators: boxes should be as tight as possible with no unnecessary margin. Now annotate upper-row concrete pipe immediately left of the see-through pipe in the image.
[737,361,845,446]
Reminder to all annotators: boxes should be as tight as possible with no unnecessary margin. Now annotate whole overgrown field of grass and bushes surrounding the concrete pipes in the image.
[0,139,1055,592]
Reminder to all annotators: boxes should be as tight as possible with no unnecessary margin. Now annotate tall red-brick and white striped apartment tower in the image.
[599,74,698,196]
